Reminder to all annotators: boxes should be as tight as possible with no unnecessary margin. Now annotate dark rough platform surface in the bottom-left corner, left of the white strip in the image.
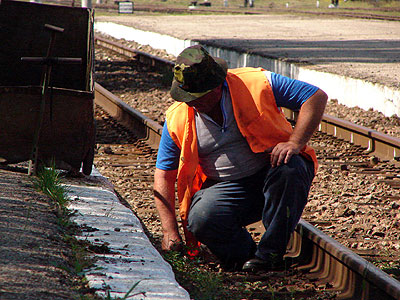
[0,169,86,300]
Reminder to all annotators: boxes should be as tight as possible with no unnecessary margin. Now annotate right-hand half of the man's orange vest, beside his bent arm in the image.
[227,68,318,173]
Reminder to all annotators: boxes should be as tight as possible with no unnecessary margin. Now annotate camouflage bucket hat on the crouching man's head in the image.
[170,45,228,102]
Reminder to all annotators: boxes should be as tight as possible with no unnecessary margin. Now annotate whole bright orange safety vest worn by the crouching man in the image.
[166,68,318,246]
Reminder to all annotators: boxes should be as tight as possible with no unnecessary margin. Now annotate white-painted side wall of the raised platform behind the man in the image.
[94,22,400,116]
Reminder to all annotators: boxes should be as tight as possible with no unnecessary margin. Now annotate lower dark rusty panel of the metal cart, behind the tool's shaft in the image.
[0,87,94,170]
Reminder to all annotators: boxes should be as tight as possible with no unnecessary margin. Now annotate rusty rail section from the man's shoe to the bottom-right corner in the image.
[288,219,400,300]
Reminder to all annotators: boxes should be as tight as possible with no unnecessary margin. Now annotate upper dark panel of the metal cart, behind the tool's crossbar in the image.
[0,0,94,91]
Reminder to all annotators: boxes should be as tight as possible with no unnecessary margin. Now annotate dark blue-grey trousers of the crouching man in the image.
[188,155,314,266]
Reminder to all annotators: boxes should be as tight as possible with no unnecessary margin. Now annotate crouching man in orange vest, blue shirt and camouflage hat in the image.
[154,45,327,272]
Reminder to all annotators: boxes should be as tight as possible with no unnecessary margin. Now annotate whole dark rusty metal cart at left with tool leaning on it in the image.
[0,0,95,174]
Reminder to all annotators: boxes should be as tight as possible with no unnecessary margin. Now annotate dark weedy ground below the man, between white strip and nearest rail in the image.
[163,247,335,300]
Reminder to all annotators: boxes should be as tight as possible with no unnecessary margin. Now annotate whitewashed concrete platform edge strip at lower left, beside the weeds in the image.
[67,169,190,300]
